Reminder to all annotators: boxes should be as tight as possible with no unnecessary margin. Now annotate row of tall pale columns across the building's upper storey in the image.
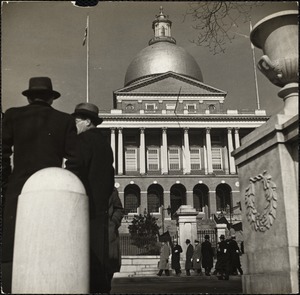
[111,127,240,175]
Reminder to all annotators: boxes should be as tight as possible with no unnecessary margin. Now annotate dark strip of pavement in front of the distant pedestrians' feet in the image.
[111,275,243,294]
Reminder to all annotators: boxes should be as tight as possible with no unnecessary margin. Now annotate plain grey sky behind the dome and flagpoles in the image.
[1,1,298,115]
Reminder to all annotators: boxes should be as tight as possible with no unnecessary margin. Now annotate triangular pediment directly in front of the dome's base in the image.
[115,72,226,96]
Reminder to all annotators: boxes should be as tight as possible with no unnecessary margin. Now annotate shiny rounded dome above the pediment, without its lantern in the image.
[125,41,203,86]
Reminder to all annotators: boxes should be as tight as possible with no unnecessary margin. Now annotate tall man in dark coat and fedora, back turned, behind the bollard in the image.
[1,77,77,293]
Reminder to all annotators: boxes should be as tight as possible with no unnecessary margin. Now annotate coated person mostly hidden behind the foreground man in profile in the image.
[107,188,124,289]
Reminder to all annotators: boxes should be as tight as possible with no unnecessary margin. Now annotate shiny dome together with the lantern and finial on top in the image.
[124,7,203,86]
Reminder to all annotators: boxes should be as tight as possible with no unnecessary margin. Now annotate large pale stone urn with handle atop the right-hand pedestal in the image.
[250,10,299,112]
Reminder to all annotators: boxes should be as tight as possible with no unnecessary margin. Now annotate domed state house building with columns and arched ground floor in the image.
[99,8,268,236]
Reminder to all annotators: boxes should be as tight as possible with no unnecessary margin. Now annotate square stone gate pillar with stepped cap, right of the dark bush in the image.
[176,205,198,261]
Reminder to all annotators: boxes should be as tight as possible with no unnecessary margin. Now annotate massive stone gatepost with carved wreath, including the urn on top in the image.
[232,11,299,294]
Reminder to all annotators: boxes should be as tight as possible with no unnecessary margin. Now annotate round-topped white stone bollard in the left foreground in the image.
[12,167,89,294]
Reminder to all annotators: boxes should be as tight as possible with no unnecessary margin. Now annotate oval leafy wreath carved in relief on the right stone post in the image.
[245,170,277,232]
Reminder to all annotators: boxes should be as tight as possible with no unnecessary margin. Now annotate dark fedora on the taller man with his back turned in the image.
[22,77,60,99]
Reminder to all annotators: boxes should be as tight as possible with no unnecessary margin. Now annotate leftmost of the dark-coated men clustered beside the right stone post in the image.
[214,235,229,280]
